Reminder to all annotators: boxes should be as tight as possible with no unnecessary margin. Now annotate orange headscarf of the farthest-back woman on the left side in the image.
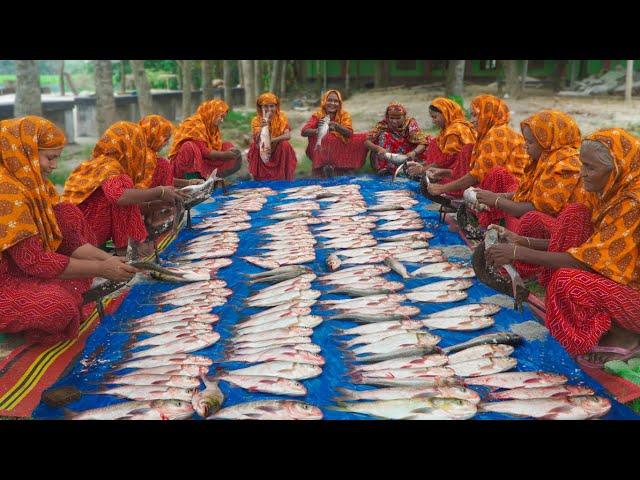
[169,100,229,157]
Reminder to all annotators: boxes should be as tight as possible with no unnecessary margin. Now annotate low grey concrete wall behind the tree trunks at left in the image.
[75,88,244,137]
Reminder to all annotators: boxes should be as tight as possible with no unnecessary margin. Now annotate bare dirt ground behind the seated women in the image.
[54,81,640,187]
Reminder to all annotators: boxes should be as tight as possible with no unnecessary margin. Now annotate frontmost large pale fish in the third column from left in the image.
[327,397,477,420]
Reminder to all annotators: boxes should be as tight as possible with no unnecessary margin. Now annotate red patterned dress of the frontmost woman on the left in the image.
[0,203,95,343]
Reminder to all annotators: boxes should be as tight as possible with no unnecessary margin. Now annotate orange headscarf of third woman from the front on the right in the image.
[469,95,530,182]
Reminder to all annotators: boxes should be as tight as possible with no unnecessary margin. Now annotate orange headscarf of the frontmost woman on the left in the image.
[0,116,66,257]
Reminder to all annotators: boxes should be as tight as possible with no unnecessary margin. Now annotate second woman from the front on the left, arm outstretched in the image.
[62,122,184,253]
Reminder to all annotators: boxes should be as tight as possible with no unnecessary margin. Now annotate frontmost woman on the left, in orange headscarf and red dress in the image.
[0,116,137,343]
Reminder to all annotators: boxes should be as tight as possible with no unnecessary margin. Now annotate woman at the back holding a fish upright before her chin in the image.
[247,92,298,181]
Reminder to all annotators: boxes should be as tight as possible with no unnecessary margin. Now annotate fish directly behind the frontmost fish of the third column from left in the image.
[335,385,480,405]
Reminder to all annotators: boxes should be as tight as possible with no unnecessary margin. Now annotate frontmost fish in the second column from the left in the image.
[209,400,322,420]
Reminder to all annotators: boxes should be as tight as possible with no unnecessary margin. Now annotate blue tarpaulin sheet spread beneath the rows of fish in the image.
[33,176,638,420]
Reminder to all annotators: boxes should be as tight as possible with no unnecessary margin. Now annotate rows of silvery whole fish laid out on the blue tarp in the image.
[67,184,611,420]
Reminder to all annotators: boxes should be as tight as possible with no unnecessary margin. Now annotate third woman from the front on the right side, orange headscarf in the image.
[428,95,529,203]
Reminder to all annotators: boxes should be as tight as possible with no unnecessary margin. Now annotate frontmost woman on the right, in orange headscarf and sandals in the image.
[486,128,640,366]
